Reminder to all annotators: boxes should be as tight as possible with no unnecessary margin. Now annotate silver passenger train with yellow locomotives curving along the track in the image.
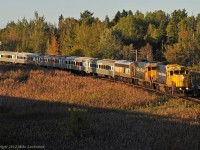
[0,51,192,94]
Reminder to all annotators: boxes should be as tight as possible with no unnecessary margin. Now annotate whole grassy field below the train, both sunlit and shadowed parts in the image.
[0,64,200,150]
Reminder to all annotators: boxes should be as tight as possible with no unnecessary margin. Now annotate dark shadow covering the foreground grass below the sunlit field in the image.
[0,96,200,150]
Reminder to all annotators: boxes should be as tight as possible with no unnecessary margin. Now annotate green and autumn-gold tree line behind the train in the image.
[0,9,200,66]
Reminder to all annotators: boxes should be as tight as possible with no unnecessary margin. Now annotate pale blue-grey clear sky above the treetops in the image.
[0,0,200,28]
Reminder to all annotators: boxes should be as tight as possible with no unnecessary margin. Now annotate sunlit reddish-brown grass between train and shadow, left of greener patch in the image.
[0,64,156,109]
